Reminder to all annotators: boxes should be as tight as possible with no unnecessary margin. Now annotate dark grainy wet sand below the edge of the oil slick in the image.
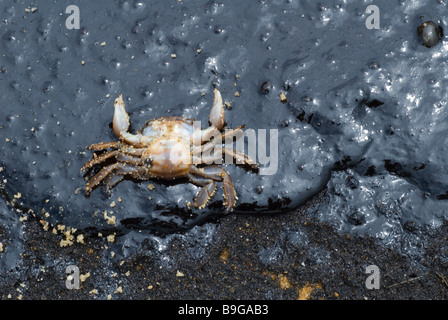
[0,189,448,300]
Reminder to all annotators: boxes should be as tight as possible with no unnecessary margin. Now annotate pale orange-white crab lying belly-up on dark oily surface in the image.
[81,89,258,212]
